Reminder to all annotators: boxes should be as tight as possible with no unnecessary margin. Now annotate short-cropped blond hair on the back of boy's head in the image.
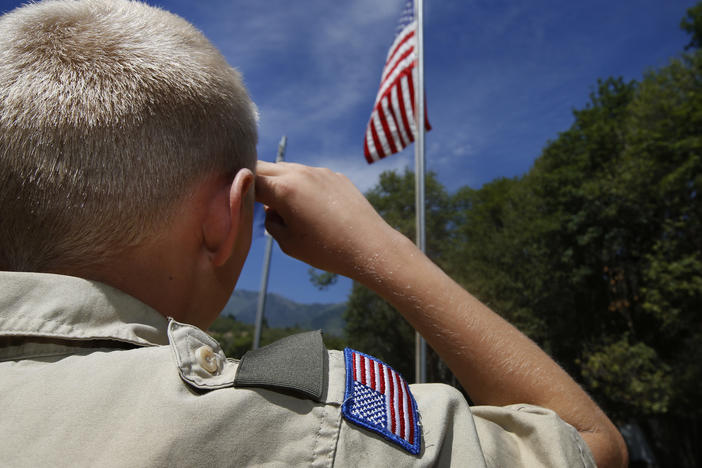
[0,0,257,271]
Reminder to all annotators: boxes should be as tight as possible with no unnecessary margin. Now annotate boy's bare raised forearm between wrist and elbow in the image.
[356,233,626,466]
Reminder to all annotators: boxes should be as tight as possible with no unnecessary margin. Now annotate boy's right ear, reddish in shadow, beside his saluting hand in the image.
[202,169,254,267]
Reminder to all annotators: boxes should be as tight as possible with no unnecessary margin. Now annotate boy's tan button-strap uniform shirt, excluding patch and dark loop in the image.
[0,272,594,467]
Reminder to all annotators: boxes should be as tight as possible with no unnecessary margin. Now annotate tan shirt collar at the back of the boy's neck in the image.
[0,271,168,346]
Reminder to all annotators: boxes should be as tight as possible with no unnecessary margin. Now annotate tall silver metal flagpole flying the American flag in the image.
[414,0,427,383]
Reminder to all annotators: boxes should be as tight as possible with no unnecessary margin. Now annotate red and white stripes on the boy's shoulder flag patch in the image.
[353,352,414,444]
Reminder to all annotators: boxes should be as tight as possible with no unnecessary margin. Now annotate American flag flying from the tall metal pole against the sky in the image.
[363,1,431,163]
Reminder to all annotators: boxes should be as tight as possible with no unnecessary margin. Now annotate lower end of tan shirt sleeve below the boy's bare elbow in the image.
[471,404,596,468]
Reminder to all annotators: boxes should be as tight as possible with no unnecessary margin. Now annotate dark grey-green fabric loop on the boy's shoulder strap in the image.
[234,330,327,401]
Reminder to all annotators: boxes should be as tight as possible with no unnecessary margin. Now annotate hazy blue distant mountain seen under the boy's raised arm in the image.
[221,290,346,336]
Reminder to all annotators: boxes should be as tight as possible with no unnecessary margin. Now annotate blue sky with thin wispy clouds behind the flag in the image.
[0,0,696,308]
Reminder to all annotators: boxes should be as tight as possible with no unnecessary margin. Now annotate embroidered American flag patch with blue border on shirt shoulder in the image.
[341,348,421,455]
